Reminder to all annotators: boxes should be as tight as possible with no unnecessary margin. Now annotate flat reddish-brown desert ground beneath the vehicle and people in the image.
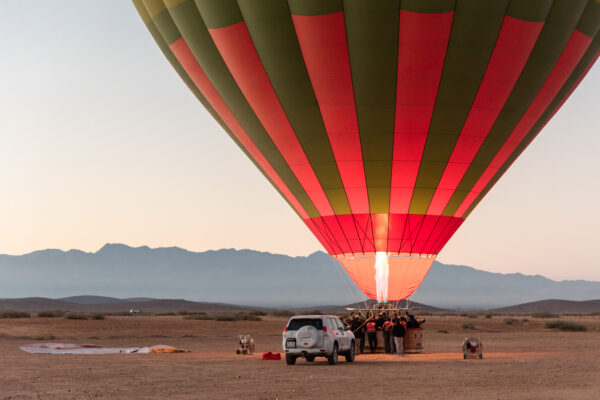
[0,315,600,400]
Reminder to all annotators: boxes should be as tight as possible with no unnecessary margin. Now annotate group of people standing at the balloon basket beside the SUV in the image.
[346,311,425,356]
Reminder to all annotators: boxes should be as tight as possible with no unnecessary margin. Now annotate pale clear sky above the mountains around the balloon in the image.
[0,0,600,280]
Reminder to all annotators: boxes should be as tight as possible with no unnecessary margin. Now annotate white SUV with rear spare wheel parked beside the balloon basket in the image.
[282,315,356,365]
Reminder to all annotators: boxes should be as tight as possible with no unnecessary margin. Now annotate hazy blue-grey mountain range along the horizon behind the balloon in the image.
[0,244,600,309]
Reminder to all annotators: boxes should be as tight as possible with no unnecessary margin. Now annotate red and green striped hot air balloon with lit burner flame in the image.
[134,0,600,302]
